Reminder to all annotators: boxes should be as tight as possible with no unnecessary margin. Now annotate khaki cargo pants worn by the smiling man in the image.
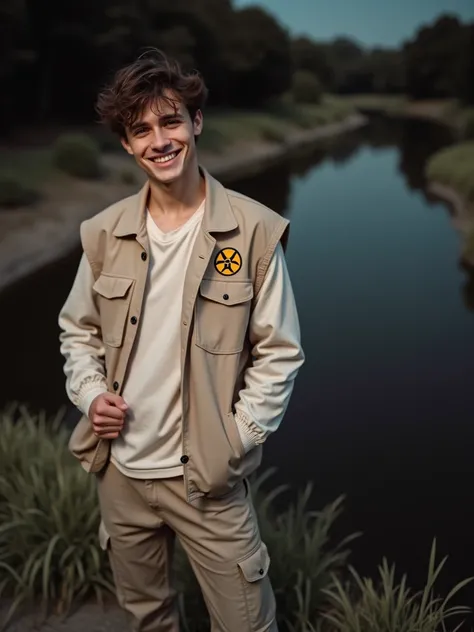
[97,463,278,632]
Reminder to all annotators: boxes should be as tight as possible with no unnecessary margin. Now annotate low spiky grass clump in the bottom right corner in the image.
[323,540,473,632]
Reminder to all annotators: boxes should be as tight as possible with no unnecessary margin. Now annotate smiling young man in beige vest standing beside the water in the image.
[59,50,303,632]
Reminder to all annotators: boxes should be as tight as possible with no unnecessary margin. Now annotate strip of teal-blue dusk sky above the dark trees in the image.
[234,0,474,46]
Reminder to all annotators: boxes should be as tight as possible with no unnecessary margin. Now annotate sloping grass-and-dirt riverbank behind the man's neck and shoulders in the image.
[0,113,366,291]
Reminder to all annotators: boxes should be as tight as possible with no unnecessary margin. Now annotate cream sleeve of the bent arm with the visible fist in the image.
[58,254,108,415]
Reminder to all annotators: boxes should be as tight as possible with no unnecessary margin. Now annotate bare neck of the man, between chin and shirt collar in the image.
[148,159,205,215]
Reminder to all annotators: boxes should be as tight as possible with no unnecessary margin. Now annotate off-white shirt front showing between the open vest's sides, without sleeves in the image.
[111,202,204,478]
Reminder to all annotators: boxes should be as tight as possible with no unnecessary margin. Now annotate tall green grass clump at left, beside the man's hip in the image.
[0,406,114,625]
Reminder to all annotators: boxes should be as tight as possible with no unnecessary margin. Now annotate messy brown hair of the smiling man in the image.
[96,49,208,138]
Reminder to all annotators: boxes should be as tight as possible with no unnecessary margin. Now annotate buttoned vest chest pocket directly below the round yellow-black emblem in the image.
[195,279,253,354]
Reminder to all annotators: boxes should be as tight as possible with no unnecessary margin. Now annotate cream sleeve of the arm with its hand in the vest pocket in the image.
[235,244,305,452]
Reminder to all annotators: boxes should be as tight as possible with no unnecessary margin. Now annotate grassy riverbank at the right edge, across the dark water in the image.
[426,141,474,269]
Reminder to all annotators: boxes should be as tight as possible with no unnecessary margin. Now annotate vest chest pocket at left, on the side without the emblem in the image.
[93,274,134,347]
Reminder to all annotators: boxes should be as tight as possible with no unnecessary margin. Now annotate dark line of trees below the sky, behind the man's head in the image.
[0,0,474,130]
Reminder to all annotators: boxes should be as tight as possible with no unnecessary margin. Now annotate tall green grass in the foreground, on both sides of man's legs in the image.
[0,407,469,632]
